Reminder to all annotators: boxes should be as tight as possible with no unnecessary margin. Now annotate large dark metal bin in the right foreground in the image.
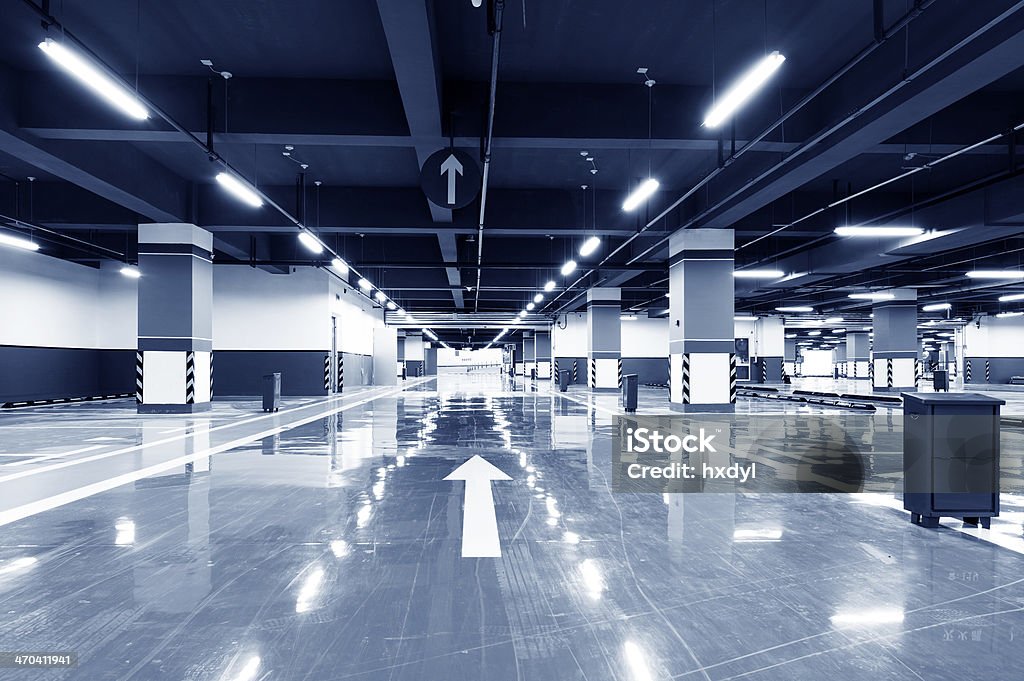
[902,392,1006,527]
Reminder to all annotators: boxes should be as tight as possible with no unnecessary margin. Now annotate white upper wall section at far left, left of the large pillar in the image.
[0,248,138,349]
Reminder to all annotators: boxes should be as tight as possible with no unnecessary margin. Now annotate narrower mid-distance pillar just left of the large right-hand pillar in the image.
[587,288,623,392]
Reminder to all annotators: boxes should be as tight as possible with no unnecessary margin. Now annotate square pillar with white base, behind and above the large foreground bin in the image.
[871,289,920,392]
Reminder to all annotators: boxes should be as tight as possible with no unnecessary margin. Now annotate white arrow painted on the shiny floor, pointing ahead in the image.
[444,455,512,558]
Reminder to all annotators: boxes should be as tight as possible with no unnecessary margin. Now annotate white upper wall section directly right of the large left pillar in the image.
[214,265,329,350]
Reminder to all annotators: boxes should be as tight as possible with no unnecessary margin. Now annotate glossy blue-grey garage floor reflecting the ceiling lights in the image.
[0,374,1024,681]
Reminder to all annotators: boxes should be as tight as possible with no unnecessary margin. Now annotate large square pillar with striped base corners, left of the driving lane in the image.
[135,223,213,414]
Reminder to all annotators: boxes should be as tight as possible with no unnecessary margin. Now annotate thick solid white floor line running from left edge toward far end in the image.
[0,376,434,526]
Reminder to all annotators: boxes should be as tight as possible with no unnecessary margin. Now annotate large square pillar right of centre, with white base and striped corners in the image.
[669,229,736,412]
